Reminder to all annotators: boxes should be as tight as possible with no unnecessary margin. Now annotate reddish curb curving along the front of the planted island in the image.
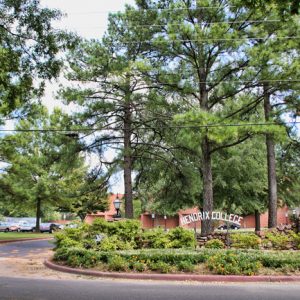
[44,260,300,282]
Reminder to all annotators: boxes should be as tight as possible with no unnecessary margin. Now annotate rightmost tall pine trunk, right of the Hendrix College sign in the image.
[264,84,277,228]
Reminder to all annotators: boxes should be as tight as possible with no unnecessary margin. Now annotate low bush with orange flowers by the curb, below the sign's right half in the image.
[207,251,261,275]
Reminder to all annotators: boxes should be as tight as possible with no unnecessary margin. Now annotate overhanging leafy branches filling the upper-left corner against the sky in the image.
[0,0,74,119]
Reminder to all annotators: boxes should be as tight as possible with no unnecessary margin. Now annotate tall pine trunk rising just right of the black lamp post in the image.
[124,94,133,219]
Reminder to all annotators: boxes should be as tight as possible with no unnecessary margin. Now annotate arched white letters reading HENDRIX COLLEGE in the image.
[180,211,243,225]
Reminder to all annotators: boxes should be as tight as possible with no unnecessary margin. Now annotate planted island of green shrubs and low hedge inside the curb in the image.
[54,219,300,275]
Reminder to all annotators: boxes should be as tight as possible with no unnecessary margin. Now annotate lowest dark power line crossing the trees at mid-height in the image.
[0,121,300,133]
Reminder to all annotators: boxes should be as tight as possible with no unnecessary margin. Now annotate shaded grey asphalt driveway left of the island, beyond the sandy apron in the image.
[0,240,54,258]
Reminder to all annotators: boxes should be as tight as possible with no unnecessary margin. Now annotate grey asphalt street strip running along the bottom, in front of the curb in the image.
[0,277,300,300]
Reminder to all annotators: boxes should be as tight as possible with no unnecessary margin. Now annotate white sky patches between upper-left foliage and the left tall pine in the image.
[40,0,135,193]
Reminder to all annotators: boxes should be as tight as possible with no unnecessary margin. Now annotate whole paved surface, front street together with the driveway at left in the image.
[0,241,300,300]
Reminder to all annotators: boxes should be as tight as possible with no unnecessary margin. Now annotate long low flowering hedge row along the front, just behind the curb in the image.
[54,247,300,275]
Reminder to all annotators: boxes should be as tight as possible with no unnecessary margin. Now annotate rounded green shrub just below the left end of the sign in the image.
[167,227,196,248]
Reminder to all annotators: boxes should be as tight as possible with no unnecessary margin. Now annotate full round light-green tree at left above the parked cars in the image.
[0,106,94,230]
